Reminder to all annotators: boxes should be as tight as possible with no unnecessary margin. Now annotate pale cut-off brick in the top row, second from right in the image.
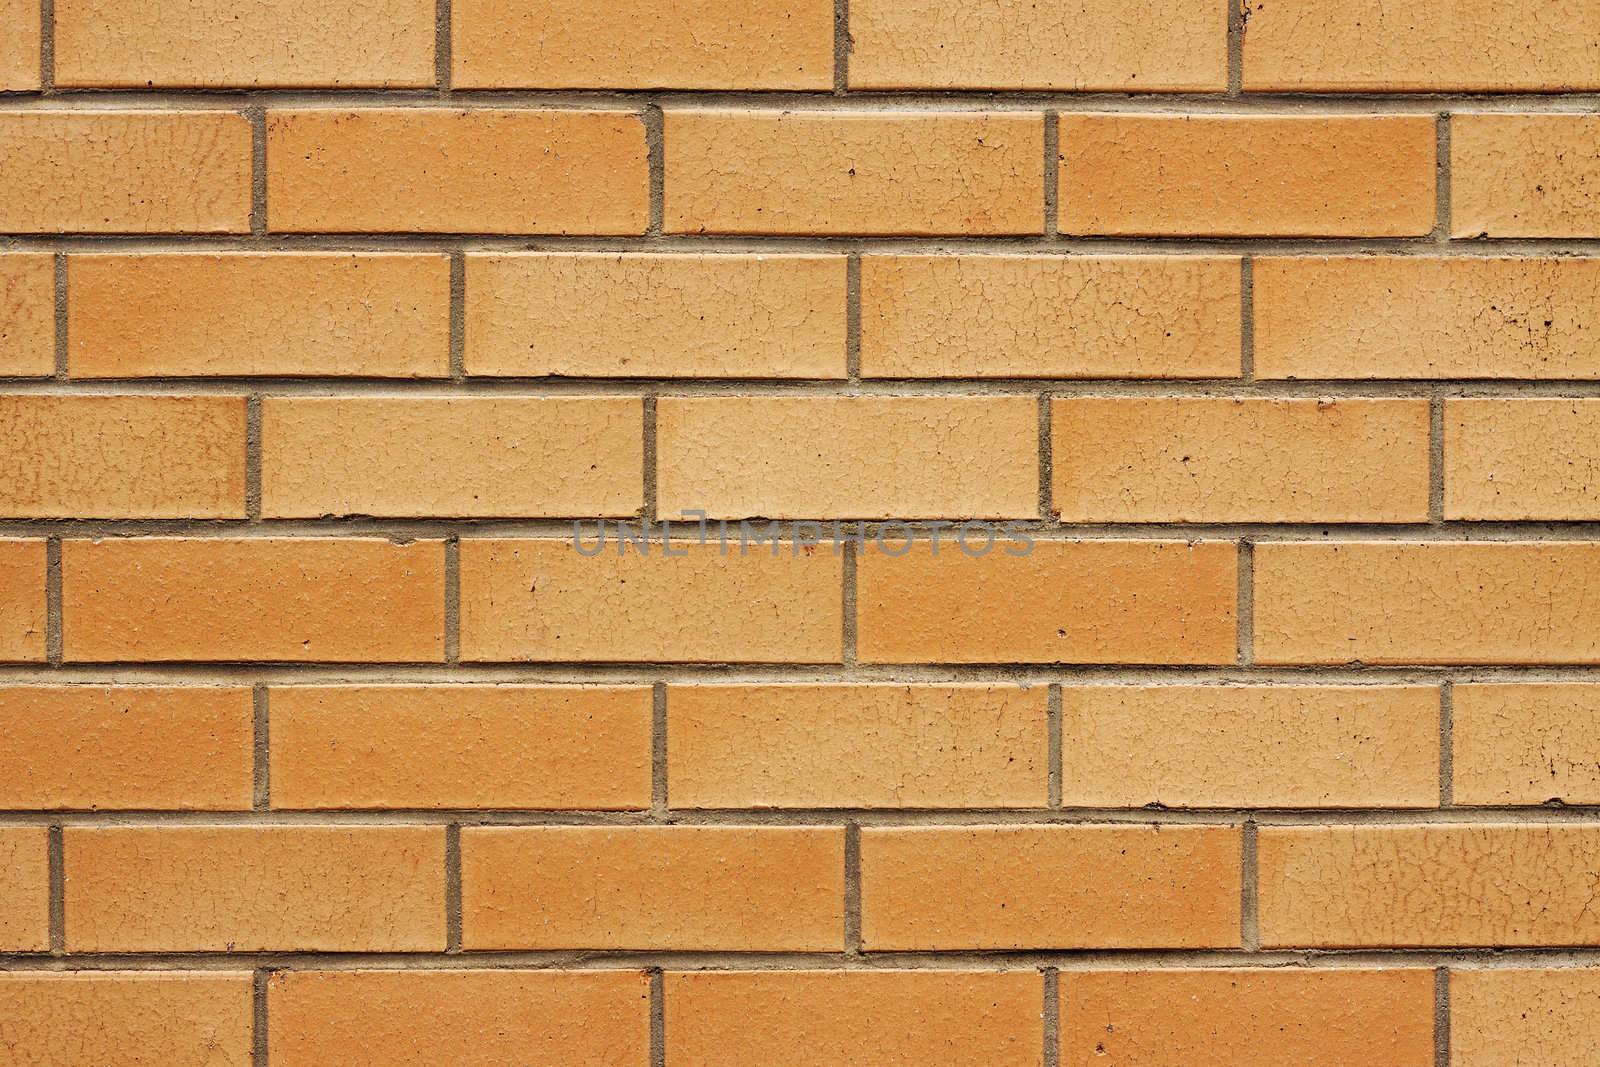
[850,0,1227,93]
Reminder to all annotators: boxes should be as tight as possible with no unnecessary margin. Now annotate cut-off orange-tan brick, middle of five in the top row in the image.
[451,0,834,90]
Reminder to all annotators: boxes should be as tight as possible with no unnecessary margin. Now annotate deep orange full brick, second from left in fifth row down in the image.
[62,537,445,662]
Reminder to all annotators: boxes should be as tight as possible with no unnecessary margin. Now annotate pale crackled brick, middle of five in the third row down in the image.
[466,253,845,378]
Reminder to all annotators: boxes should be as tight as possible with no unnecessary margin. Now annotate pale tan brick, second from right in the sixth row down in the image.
[1061,685,1438,808]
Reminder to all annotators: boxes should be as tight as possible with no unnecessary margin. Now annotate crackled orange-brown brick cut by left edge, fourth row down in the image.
[0,395,245,518]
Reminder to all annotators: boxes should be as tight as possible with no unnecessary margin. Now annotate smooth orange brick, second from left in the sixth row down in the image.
[270,685,651,808]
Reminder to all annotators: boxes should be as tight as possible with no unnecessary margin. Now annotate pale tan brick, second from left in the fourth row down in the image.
[261,397,645,518]
